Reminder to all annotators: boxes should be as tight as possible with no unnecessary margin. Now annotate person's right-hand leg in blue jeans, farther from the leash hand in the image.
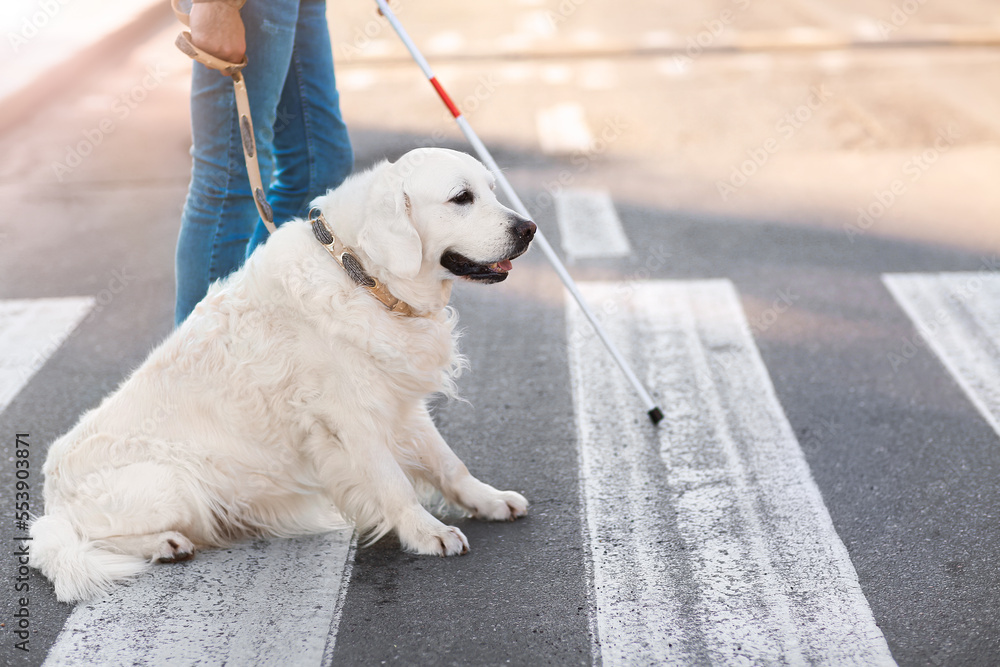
[246,0,354,256]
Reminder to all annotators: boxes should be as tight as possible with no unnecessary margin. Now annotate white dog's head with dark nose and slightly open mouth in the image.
[357,148,536,283]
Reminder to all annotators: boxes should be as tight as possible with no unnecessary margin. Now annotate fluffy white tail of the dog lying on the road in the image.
[29,515,149,602]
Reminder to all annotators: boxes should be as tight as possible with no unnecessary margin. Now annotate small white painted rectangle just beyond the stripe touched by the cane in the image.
[555,189,632,262]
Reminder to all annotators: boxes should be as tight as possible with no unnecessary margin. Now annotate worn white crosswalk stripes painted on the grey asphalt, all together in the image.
[0,200,1000,666]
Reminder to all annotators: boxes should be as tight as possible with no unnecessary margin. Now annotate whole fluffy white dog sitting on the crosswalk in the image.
[31,149,535,601]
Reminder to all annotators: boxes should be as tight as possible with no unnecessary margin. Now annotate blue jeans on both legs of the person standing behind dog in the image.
[174,0,354,324]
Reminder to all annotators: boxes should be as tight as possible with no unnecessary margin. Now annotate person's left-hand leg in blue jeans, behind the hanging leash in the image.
[174,0,298,324]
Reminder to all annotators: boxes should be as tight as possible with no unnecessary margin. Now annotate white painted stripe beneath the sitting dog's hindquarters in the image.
[44,529,353,667]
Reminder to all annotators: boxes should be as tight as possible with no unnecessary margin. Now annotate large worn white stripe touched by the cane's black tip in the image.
[567,280,894,666]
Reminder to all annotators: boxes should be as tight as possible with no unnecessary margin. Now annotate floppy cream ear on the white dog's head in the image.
[358,170,423,279]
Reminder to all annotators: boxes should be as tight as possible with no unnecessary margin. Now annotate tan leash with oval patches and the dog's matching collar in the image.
[170,0,432,317]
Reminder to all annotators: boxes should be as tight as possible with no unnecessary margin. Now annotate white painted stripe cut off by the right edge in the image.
[882,272,1000,435]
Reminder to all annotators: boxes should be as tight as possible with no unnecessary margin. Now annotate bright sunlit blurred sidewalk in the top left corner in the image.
[0,0,173,131]
